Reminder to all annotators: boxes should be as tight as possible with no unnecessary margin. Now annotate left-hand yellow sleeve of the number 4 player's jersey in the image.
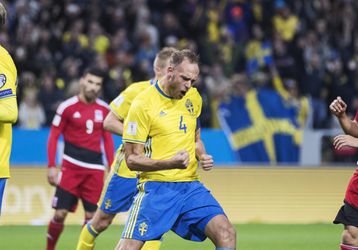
[123,98,150,144]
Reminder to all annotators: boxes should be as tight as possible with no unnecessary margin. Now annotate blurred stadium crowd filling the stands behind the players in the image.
[0,0,358,129]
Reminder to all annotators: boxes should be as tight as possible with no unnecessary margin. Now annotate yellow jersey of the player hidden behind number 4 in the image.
[109,80,151,178]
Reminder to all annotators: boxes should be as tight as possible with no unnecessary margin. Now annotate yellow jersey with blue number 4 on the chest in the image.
[123,83,202,182]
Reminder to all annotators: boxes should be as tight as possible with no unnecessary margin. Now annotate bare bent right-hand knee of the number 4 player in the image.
[205,214,236,250]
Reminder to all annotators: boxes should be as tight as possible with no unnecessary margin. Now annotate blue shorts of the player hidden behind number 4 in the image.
[99,174,138,214]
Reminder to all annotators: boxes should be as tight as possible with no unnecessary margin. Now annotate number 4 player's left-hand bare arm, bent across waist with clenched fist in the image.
[124,142,189,172]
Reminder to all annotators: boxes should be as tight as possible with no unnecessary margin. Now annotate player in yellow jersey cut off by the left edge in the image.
[0,3,18,213]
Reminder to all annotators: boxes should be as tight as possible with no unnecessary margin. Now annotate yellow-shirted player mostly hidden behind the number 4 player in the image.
[77,47,176,250]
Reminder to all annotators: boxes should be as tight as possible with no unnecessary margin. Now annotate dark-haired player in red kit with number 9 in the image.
[46,68,114,250]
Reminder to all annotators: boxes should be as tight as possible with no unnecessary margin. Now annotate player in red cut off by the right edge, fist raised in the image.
[329,96,358,250]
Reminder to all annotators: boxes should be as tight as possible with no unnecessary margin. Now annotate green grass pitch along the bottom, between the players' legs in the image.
[0,224,343,250]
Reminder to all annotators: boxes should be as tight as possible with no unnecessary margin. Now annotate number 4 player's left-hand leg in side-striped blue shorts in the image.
[116,181,185,249]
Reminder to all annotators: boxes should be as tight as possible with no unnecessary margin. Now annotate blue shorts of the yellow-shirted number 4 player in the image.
[122,181,225,241]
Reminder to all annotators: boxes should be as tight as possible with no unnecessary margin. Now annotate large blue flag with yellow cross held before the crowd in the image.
[218,89,301,163]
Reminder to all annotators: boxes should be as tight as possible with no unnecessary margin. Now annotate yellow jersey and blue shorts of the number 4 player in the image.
[122,83,224,241]
